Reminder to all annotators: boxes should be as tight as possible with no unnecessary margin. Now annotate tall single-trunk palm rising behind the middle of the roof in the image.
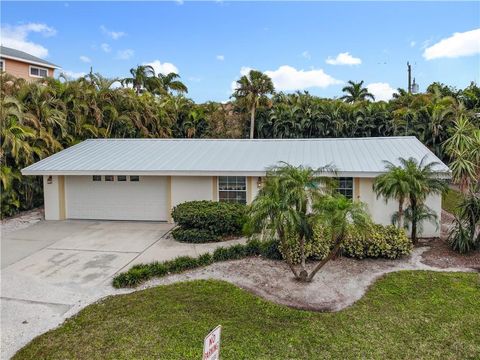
[233,70,275,139]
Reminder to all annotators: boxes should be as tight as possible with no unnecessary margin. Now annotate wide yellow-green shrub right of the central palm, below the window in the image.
[342,224,413,259]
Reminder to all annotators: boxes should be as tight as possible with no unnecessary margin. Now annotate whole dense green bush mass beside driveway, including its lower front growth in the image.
[172,201,246,243]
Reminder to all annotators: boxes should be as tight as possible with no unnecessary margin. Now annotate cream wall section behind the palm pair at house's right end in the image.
[354,178,442,237]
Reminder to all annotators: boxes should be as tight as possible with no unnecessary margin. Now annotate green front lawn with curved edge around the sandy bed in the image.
[15,271,480,360]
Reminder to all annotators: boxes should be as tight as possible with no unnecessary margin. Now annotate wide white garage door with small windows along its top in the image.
[65,176,168,221]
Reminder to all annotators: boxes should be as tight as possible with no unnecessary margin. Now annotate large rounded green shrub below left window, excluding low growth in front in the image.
[172,201,246,236]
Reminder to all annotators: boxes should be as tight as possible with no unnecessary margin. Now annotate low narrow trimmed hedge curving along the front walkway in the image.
[112,239,282,288]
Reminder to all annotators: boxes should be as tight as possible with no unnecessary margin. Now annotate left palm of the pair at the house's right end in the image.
[373,161,410,229]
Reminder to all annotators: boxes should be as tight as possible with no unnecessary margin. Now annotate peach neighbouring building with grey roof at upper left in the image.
[0,46,60,80]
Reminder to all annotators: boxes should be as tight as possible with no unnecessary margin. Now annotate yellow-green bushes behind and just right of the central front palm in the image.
[279,224,413,264]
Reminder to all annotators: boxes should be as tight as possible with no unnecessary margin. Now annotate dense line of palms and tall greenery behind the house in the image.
[0,66,480,217]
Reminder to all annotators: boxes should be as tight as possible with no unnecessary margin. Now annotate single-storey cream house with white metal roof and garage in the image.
[22,137,450,236]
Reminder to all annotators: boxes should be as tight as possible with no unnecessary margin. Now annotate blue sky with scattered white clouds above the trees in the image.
[0,0,480,102]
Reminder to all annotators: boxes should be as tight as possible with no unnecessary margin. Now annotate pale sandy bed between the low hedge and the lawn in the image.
[141,247,470,311]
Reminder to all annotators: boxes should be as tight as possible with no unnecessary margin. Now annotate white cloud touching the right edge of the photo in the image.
[423,28,480,60]
